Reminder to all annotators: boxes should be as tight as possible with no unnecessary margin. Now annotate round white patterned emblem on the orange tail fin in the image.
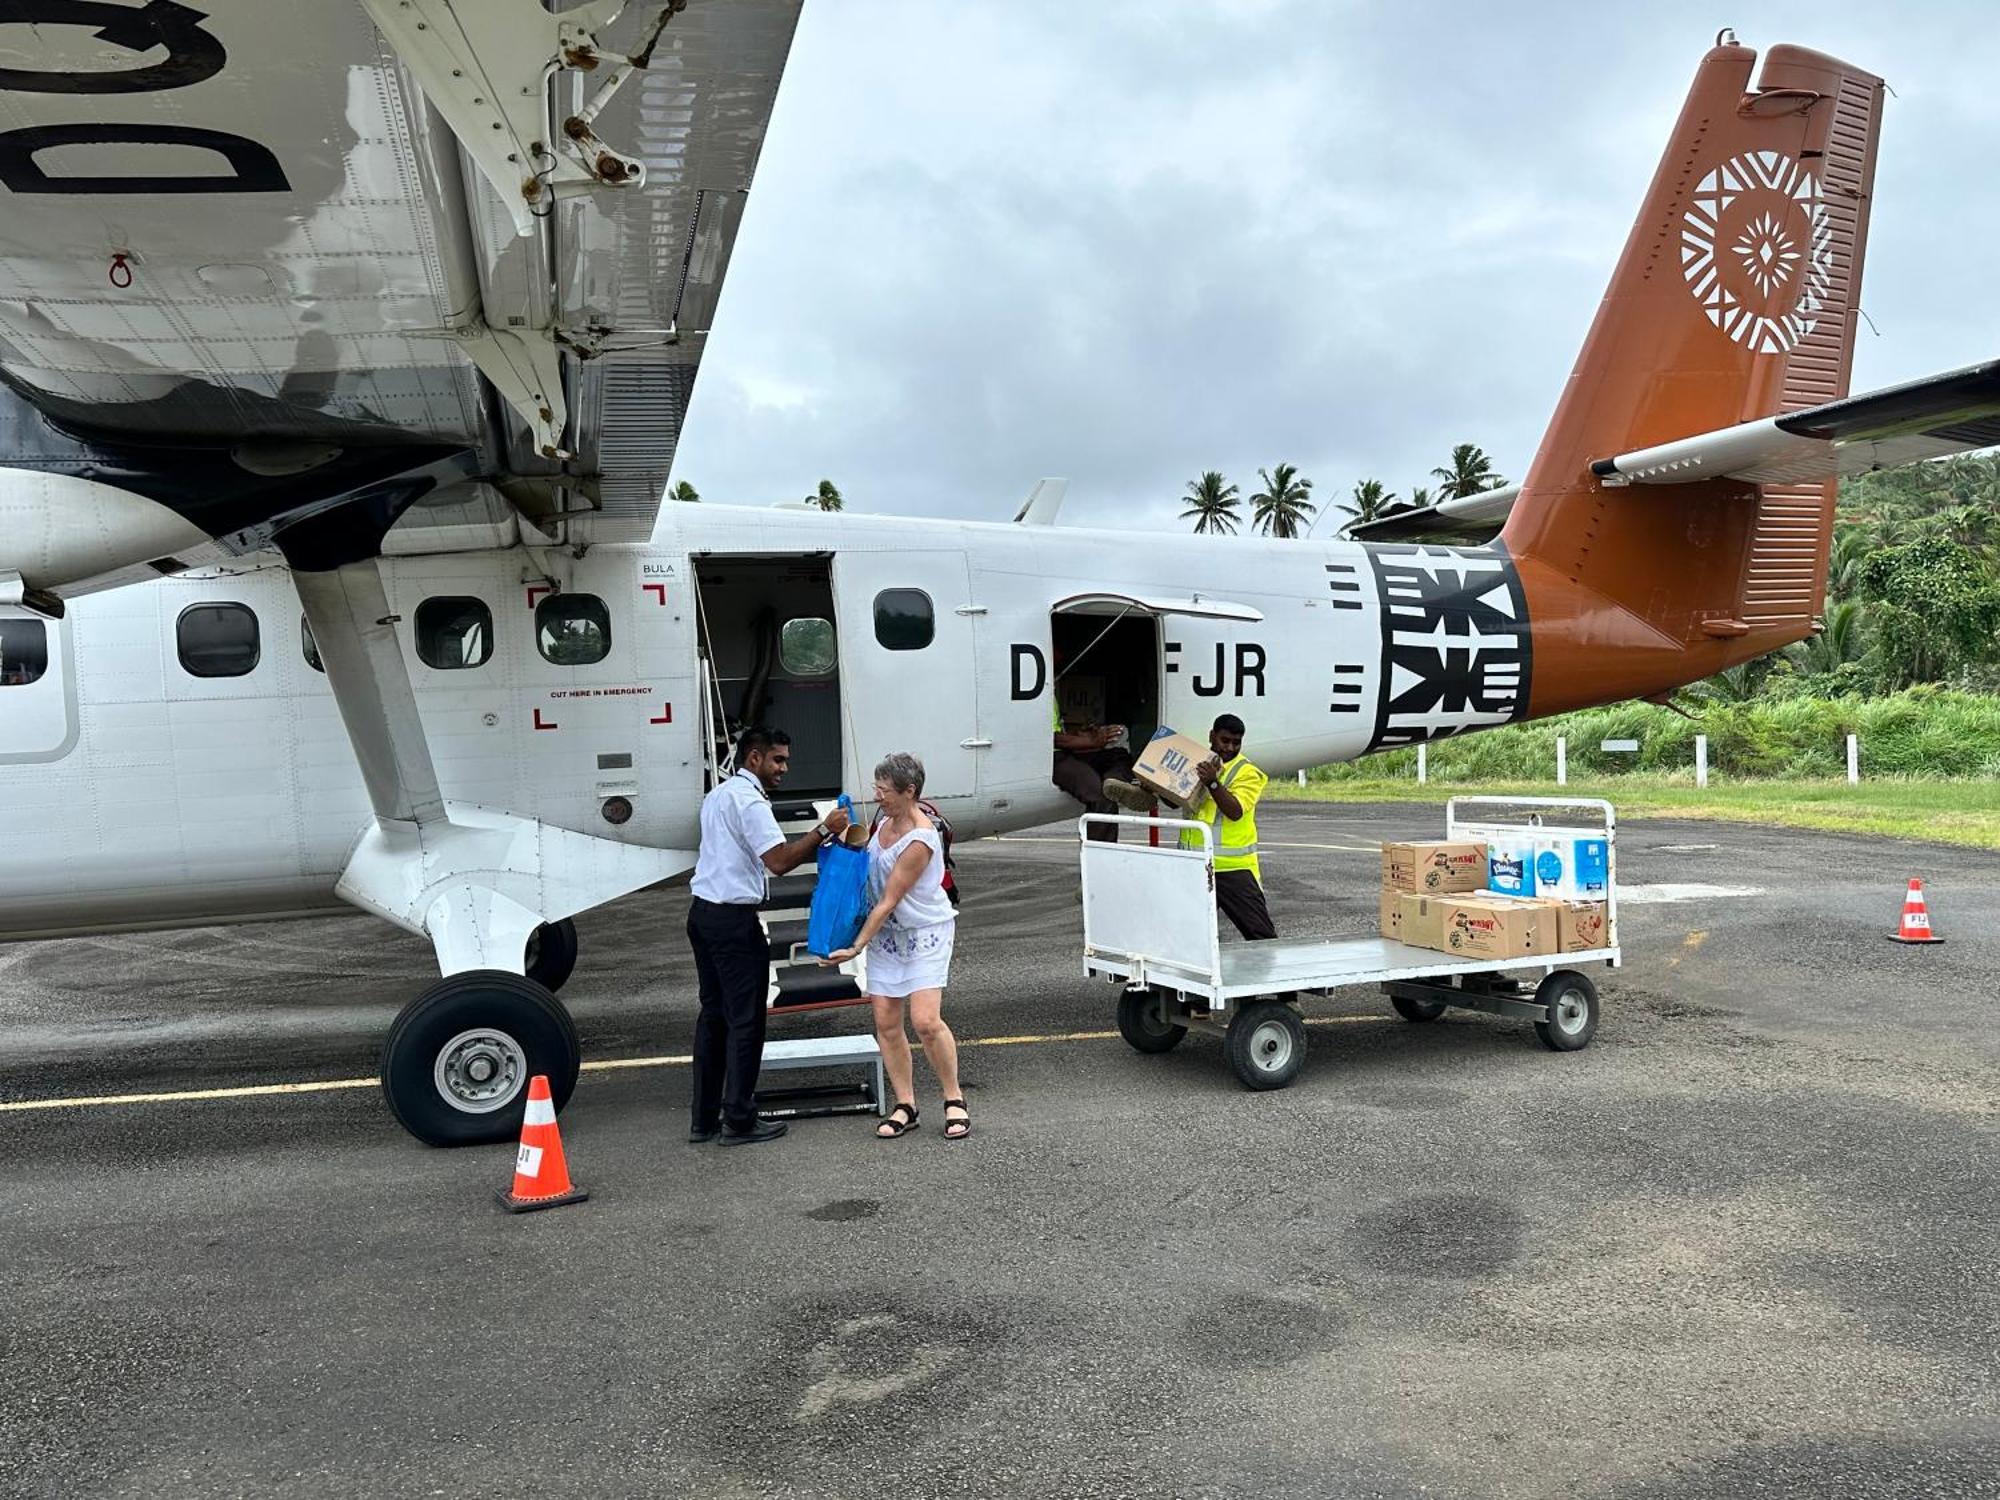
[1680,152,1834,354]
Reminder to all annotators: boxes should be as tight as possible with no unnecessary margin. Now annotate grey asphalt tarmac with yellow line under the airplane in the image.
[0,806,2000,1500]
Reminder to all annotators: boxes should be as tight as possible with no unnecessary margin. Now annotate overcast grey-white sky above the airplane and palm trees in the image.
[676,0,2000,528]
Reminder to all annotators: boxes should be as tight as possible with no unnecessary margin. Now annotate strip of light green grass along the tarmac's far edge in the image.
[1266,776,2000,850]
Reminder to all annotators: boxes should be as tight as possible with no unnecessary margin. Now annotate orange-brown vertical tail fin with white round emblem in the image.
[1502,38,1882,714]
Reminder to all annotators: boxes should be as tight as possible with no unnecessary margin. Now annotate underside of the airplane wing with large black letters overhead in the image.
[0,0,800,592]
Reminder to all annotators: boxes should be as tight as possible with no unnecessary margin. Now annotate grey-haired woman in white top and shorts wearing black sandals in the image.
[826,750,972,1140]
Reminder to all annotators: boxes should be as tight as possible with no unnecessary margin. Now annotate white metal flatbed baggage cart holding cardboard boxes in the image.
[1076,796,1620,1090]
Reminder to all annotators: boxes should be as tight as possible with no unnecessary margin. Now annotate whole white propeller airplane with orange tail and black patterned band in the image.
[0,11,2000,1144]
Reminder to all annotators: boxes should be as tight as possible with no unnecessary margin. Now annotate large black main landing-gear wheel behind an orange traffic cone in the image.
[382,968,580,1146]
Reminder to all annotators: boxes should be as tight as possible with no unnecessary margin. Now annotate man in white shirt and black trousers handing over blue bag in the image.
[688,728,848,1146]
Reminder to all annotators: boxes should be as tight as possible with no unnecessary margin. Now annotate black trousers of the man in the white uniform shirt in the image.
[688,896,770,1130]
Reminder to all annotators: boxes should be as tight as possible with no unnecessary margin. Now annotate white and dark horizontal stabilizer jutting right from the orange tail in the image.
[1590,360,2000,484]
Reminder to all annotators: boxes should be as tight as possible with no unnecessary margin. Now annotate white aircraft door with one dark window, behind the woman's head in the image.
[834,552,992,798]
